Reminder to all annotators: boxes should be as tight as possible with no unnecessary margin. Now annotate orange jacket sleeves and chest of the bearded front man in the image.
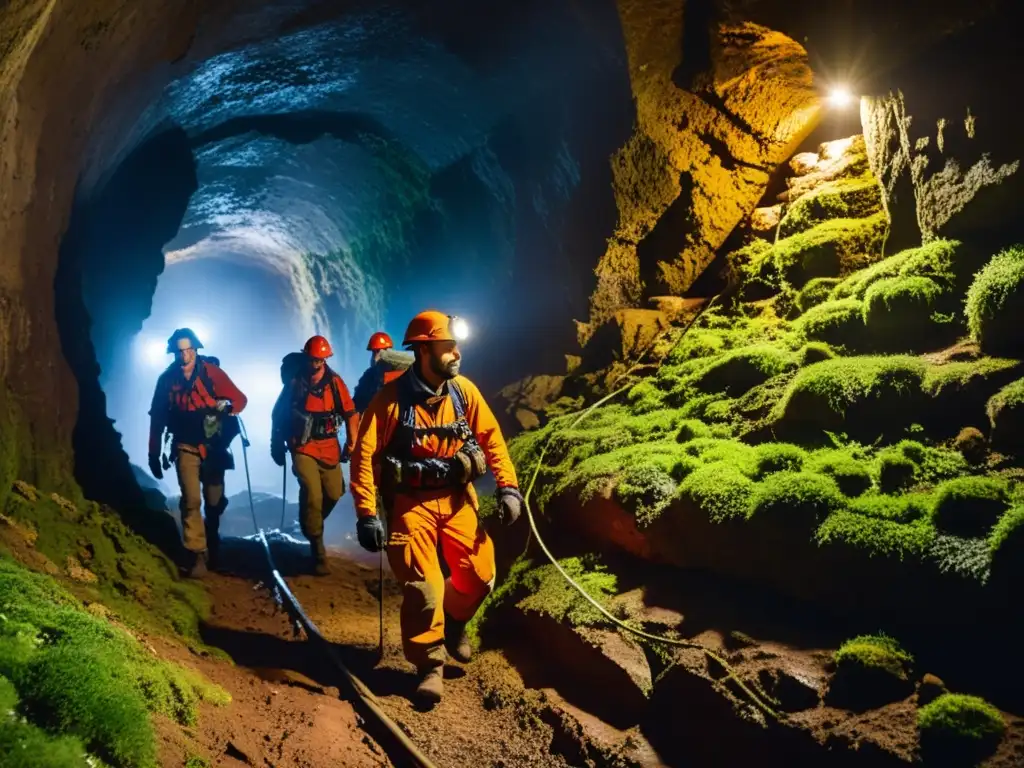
[351,372,518,517]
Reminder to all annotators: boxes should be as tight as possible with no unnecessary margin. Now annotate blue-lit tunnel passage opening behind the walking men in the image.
[56,2,633,514]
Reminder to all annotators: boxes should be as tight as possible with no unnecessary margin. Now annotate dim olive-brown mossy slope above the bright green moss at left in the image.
[5,494,209,642]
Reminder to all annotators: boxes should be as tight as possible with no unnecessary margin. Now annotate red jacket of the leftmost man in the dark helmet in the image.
[150,357,249,454]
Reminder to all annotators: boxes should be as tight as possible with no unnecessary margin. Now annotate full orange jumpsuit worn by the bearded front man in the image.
[351,371,518,670]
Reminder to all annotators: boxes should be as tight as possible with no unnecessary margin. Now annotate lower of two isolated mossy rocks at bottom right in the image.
[918,693,1007,765]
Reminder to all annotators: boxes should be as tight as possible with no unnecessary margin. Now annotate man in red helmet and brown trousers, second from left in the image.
[270,336,359,575]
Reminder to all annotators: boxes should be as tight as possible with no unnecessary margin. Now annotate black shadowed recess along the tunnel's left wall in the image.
[54,127,198,552]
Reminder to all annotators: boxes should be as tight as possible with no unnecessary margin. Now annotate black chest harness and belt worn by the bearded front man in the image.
[381,376,487,492]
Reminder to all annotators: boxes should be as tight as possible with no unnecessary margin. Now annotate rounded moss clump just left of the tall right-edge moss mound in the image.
[863,278,956,352]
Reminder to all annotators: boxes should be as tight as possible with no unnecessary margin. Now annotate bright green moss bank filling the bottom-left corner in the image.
[0,561,228,766]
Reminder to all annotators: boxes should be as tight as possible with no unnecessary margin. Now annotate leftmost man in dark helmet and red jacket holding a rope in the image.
[150,328,248,579]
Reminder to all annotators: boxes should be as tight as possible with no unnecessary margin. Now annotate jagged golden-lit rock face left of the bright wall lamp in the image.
[580,6,818,340]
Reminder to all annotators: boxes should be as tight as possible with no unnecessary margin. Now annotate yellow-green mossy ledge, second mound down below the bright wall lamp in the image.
[771,213,887,288]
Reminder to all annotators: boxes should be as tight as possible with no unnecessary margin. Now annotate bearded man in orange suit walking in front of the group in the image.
[351,311,524,705]
